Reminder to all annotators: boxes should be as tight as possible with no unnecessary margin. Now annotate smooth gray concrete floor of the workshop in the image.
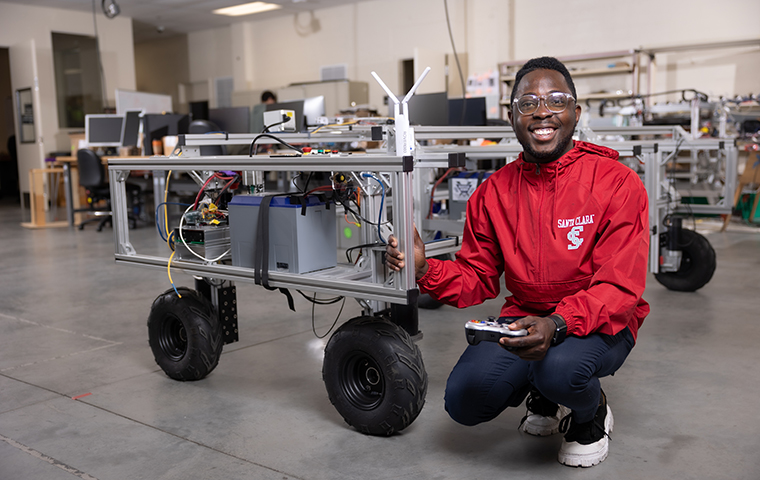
[0,200,760,480]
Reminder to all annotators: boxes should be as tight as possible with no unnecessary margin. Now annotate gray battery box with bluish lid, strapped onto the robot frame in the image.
[228,195,338,273]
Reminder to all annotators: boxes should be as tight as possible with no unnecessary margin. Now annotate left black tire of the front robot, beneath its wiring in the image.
[148,287,224,381]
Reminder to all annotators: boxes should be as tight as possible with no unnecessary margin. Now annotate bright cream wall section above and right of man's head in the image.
[513,0,760,100]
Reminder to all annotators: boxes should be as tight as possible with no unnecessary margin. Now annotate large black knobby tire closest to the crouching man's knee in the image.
[322,317,428,436]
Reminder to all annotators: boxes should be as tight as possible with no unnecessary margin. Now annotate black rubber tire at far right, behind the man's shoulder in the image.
[654,229,716,292]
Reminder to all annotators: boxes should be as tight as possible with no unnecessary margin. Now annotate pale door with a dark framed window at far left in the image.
[8,39,48,205]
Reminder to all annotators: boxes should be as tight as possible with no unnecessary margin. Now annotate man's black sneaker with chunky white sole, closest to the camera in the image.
[557,392,615,467]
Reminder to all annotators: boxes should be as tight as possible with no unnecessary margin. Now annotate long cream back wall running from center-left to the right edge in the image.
[190,0,760,115]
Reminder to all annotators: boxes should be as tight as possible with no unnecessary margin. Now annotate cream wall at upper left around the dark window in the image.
[0,3,135,192]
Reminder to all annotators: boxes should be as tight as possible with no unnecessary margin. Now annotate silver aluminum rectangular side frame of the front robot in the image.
[108,152,434,305]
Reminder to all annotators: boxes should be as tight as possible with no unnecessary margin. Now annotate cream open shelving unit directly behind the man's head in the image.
[499,50,641,120]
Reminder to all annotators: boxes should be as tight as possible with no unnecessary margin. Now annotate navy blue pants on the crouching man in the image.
[445,328,634,425]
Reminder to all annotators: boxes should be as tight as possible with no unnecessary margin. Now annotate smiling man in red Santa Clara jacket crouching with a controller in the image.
[386,57,649,467]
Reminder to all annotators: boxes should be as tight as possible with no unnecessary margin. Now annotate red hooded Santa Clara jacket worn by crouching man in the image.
[418,142,649,338]
